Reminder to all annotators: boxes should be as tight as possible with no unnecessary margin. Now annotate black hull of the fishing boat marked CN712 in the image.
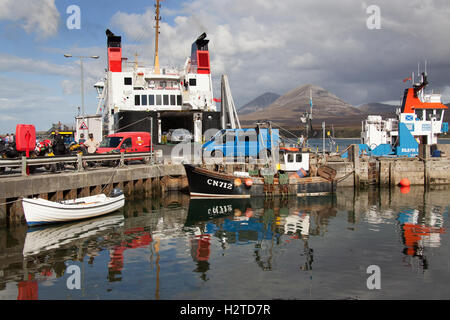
[184,164,336,199]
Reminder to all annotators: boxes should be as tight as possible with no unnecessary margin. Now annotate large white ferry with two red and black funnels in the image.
[90,0,221,143]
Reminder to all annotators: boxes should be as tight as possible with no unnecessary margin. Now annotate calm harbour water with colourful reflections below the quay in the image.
[0,188,450,300]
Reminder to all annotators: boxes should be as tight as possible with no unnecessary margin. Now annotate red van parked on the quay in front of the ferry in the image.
[96,132,153,159]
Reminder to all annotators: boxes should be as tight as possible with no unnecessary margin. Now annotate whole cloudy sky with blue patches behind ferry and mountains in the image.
[0,0,450,133]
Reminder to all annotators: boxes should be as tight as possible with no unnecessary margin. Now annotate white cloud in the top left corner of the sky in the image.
[0,0,60,38]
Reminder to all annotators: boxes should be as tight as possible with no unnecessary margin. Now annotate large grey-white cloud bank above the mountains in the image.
[105,0,450,105]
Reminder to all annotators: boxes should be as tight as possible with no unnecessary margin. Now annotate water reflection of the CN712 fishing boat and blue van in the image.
[185,196,336,274]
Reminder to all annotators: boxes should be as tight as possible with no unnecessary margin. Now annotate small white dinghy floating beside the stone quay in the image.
[22,189,125,226]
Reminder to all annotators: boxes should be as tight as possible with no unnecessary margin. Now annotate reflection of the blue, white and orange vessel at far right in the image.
[397,207,446,271]
